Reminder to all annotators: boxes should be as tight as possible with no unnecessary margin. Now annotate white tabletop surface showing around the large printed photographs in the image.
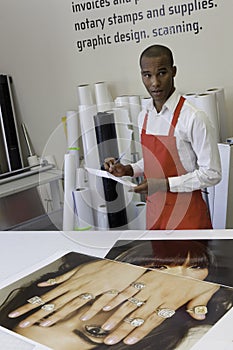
[0,230,233,350]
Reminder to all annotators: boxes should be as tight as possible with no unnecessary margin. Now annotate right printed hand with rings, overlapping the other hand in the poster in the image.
[96,271,220,345]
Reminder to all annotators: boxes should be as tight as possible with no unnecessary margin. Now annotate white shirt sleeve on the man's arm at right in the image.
[168,111,222,192]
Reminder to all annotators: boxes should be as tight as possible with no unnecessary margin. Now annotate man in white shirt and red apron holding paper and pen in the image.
[105,45,221,230]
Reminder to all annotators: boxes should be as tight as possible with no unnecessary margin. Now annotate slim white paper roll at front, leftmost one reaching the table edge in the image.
[63,154,76,231]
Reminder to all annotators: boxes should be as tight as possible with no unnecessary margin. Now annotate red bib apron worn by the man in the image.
[141,97,212,230]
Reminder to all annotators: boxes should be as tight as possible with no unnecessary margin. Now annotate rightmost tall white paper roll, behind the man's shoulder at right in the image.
[206,88,228,143]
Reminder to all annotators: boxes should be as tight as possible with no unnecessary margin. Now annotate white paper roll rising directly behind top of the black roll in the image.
[94,82,114,112]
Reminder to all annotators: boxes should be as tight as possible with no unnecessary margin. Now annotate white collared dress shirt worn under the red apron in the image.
[131,91,221,192]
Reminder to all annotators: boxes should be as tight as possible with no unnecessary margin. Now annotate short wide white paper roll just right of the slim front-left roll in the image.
[73,187,94,231]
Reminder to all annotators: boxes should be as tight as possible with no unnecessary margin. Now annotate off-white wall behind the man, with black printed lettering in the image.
[0,0,233,170]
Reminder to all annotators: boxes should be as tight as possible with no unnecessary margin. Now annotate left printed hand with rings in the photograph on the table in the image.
[8,260,146,328]
